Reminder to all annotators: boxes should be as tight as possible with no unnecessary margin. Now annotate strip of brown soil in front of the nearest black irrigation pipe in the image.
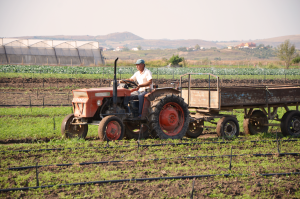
[1,176,300,198]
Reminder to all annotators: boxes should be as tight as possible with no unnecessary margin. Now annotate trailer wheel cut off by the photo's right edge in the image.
[280,111,300,137]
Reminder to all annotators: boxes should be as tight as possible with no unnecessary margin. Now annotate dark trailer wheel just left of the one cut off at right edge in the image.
[243,110,269,135]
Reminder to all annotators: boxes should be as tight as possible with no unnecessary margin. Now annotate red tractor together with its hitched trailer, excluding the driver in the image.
[61,61,300,141]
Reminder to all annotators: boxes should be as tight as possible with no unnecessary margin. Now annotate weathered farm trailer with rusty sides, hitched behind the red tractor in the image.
[178,73,300,138]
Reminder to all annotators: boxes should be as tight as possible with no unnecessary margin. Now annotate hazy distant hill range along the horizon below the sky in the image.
[13,32,300,49]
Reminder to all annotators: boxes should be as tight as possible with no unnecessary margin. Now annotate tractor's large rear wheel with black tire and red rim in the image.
[148,95,190,139]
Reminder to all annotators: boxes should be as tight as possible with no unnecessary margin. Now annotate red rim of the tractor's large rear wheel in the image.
[159,102,184,136]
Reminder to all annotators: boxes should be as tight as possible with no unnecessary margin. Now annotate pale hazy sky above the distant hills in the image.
[0,0,300,41]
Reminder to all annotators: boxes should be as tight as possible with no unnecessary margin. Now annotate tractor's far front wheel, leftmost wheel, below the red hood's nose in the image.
[60,114,88,139]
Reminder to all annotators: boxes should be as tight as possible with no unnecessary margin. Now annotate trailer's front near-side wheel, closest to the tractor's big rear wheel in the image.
[216,116,240,138]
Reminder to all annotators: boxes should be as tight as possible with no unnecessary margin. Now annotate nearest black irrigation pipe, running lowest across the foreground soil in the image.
[0,172,300,192]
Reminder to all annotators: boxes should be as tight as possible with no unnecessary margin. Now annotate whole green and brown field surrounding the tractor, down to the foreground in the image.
[0,65,300,198]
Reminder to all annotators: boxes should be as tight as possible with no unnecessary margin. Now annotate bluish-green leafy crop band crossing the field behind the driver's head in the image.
[0,65,300,75]
